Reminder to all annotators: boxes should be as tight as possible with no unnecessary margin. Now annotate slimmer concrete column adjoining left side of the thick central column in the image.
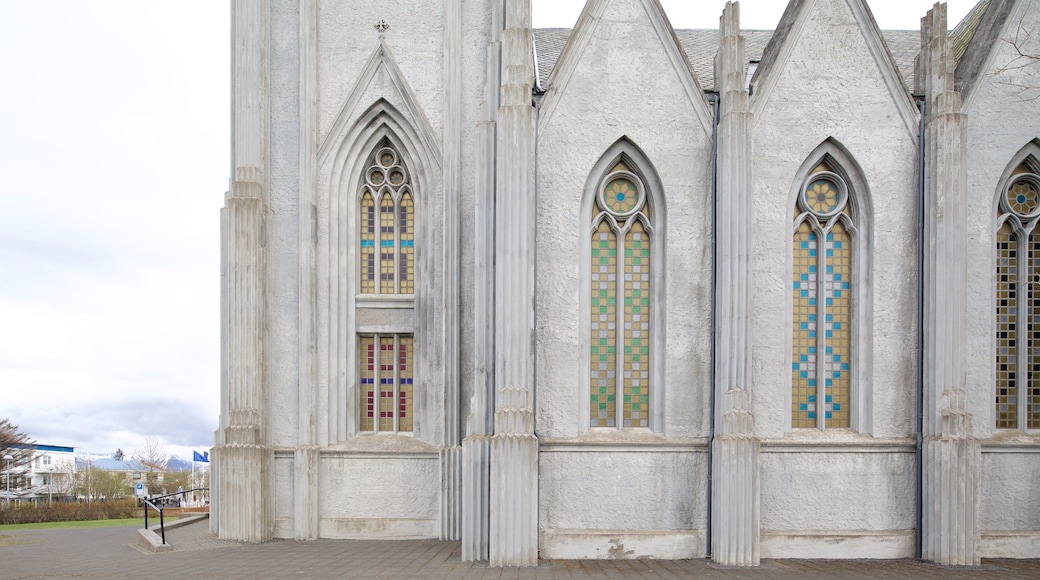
[461,2,502,561]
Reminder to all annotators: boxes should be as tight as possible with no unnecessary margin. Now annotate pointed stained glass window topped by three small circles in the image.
[359,143,416,294]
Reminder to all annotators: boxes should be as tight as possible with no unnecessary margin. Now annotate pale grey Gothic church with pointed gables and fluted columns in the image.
[210,0,1040,566]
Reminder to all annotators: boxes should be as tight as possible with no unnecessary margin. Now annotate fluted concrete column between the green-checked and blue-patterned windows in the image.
[711,2,759,565]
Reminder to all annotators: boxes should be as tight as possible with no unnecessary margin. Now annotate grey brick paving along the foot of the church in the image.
[0,521,1040,580]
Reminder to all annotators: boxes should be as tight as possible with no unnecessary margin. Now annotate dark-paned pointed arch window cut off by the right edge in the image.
[995,157,1040,429]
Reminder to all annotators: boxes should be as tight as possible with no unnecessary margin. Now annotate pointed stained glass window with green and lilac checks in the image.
[589,161,652,428]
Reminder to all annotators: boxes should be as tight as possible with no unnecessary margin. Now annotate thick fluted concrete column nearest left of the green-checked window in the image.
[489,0,538,566]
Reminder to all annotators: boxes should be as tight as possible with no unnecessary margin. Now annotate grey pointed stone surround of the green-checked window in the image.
[578,137,668,432]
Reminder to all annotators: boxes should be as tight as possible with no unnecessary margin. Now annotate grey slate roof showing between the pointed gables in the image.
[535,28,920,91]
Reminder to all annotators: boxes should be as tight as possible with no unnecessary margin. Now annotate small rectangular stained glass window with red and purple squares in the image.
[358,335,414,432]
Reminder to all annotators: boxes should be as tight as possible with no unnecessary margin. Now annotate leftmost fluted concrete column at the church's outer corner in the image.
[214,0,274,542]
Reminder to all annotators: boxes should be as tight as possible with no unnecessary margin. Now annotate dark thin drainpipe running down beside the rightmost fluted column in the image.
[914,97,925,559]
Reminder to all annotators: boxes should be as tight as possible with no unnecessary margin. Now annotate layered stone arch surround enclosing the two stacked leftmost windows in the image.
[318,99,440,442]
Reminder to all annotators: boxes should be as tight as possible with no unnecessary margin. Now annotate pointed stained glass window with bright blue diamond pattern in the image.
[791,161,857,429]
